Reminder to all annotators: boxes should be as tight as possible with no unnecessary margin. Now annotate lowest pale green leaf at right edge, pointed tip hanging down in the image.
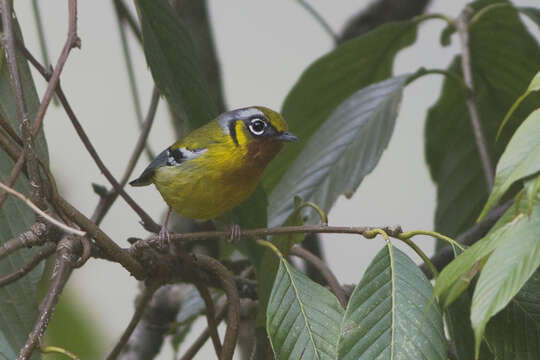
[471,203,540,351]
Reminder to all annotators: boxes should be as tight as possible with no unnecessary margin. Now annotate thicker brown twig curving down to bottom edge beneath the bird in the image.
[193,255,240,360]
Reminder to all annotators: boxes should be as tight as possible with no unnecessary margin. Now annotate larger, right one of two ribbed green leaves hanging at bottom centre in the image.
[338,244,446,360]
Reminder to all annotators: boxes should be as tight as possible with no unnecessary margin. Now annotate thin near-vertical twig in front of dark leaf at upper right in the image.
[456,8,493,188]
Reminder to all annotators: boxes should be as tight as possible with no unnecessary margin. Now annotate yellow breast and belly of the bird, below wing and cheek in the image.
[153,122,281,220]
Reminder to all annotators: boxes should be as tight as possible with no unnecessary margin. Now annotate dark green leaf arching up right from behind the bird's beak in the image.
[263,21,418,193]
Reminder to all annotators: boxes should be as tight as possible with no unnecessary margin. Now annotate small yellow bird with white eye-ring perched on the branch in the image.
[130,106,298,238]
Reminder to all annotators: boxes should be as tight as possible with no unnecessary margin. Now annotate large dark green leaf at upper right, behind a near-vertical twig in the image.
[425,1,540,236]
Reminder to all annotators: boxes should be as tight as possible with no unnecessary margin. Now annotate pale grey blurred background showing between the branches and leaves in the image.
[15,0,539,359]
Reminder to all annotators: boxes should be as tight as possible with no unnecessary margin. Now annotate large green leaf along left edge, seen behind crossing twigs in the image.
[0,16,48,359]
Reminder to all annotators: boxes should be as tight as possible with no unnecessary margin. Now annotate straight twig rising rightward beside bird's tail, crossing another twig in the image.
[91,87,159,225]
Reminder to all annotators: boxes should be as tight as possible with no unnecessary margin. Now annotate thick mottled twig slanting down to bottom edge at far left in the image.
[17,236,80,360]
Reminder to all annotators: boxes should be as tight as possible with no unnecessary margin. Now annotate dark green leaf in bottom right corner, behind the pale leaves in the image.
[480,271,540,360]
